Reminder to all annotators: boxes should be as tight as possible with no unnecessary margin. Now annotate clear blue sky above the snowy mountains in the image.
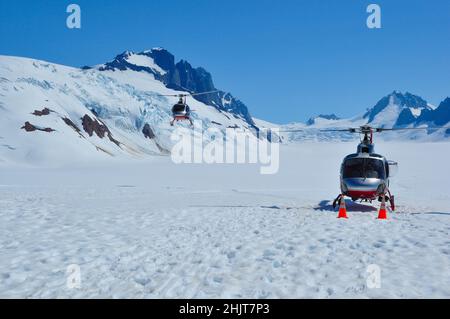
[0,0,450,123]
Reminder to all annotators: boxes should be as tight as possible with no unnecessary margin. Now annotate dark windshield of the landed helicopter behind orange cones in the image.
[343,158,386,179]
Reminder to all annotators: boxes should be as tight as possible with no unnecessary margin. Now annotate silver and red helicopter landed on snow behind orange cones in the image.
[282,125,442,215]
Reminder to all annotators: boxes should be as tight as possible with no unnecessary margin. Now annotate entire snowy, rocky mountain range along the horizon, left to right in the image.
[0,48,450,164]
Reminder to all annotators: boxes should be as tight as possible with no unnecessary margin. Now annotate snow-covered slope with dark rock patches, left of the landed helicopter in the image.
[0,50,256,165]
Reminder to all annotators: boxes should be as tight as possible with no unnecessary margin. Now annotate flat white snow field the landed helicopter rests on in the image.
[0,142,450,298]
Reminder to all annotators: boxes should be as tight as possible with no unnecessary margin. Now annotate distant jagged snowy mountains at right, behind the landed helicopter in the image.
[280,91,450,142]
